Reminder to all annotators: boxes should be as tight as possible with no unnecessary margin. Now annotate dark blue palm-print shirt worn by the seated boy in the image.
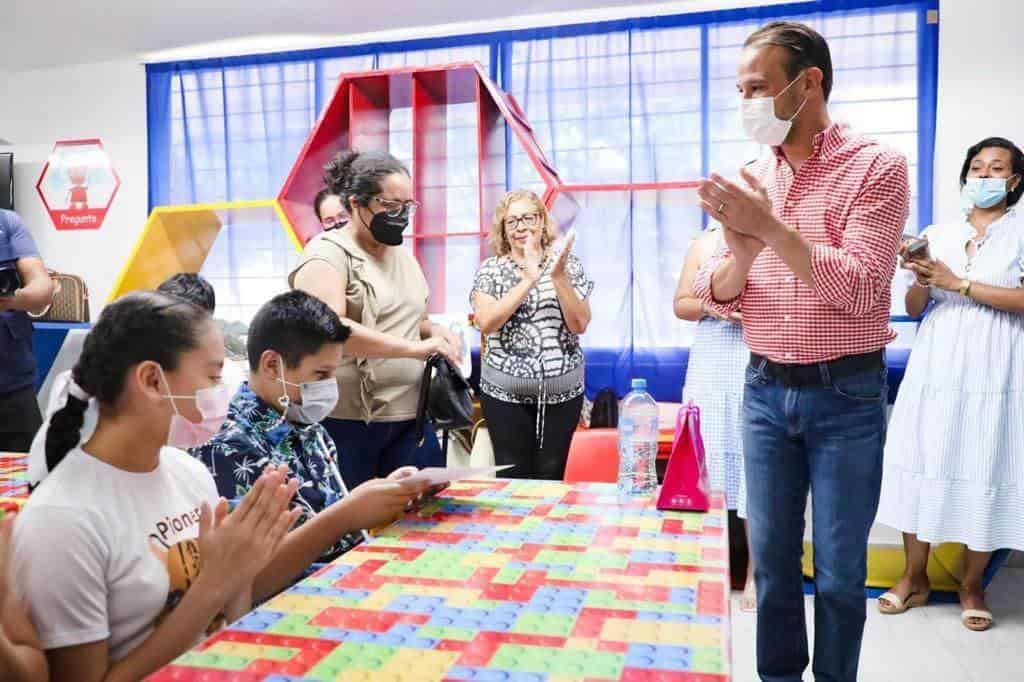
[191,383,362,561]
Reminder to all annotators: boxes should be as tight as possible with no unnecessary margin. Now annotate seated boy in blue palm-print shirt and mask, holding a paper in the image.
[191,291,425,596]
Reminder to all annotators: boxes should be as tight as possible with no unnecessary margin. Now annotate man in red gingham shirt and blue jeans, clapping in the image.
[694,23,909,682]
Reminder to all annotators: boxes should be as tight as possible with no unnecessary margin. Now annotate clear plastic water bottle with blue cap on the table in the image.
[618,379,657,498]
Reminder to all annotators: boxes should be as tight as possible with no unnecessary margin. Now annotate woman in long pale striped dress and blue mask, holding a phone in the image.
[878,137,1024,630]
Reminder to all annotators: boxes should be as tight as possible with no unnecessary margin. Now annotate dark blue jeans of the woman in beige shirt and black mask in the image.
[324,419,444,489]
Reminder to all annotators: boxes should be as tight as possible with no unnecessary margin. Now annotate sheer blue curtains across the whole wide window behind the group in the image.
[148,0,937,400]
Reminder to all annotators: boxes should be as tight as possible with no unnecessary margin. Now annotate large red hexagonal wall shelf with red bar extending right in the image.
[278,62,696,313]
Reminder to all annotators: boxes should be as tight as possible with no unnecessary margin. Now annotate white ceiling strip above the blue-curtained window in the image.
[0,0,720,71]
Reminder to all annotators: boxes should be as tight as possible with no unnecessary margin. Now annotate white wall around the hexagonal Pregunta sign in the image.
[0,60,147,319]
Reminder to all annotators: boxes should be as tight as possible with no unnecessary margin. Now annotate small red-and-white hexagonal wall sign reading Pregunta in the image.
[36,139,121,229]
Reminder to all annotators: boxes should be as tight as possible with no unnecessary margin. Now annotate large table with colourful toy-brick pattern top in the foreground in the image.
[151,479,730,682]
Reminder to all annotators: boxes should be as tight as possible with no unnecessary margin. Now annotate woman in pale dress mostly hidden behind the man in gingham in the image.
[675,228,757,611]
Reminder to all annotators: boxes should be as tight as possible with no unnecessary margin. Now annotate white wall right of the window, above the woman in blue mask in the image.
[933,0,1024,221]
